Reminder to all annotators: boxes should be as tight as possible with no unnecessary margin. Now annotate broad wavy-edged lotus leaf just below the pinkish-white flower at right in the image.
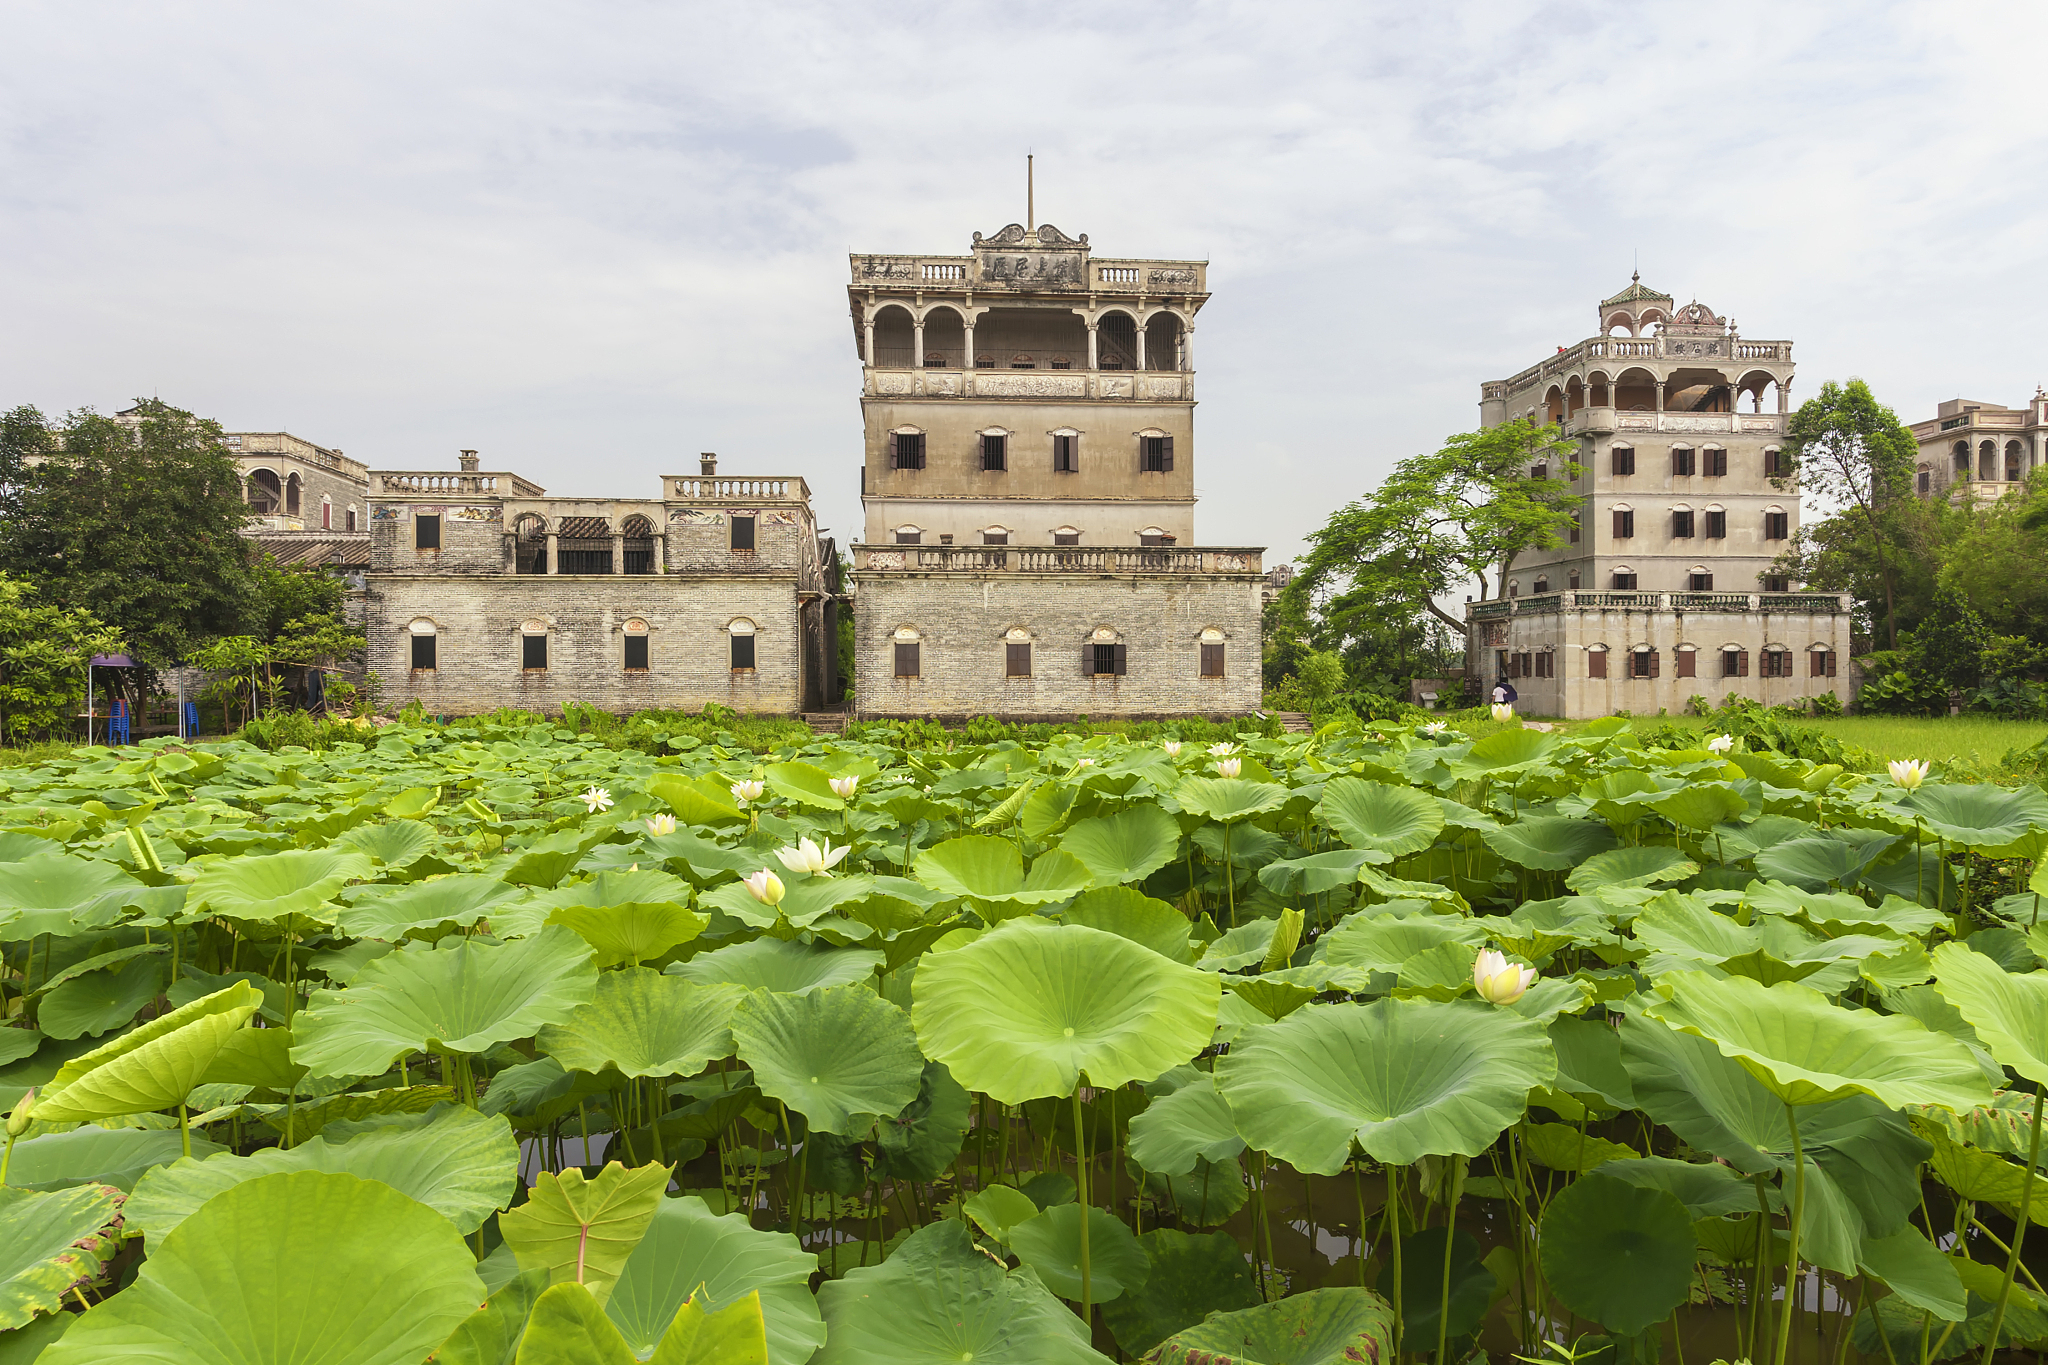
[1217,999,1556,1175]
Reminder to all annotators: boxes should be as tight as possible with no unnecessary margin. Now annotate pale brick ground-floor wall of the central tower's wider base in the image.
[852,571,1264,718]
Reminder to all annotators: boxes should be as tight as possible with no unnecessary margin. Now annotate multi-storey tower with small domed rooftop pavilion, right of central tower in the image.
[1466,278,1849,716]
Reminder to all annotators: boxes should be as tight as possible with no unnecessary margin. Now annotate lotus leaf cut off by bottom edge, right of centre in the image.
[1145,1293,1400,1365]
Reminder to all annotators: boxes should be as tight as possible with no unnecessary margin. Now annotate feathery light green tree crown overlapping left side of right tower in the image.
[1286,420,1585,654]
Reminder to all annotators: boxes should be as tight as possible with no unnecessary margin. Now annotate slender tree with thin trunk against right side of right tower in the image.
[1772,379,1919,649]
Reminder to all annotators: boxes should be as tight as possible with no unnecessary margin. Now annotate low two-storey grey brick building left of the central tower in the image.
[367,452,836,714]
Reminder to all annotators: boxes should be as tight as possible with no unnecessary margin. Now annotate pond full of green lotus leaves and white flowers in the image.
[0,720,2048,1365]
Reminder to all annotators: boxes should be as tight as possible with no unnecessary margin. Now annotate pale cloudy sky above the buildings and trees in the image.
[0,0,2048,563]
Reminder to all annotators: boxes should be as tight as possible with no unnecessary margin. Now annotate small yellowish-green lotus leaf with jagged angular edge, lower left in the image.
[498,1160,672,1304]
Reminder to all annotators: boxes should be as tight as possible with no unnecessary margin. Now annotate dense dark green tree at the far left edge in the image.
[0,399,252,667]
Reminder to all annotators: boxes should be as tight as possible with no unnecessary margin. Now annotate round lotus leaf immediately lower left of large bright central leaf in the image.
[733,986,925,1138]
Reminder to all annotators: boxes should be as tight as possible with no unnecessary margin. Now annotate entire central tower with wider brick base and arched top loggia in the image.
[848,223,1266,718]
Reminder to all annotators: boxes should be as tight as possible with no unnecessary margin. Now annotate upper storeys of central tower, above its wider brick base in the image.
[848,223,1208,546]
